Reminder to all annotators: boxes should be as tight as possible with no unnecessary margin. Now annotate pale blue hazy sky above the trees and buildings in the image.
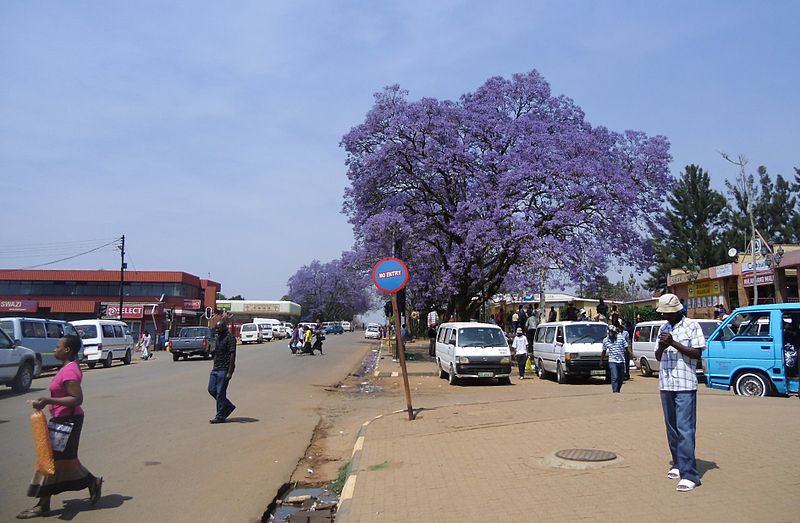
[0,0,800,299]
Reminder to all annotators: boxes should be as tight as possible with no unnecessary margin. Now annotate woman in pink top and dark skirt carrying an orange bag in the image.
[17,335,103,519]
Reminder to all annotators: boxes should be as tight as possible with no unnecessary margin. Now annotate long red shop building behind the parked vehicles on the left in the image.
[0,270,221,339]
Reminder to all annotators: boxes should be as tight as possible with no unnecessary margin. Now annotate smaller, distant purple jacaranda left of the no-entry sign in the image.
[288,260,373,321]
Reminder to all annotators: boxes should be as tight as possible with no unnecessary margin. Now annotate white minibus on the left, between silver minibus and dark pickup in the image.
[71,320,133,369]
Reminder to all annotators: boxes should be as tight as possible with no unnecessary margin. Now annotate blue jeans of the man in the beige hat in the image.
[661,390,700,484]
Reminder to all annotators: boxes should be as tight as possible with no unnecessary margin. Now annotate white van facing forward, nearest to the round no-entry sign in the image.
[436,322,511,385]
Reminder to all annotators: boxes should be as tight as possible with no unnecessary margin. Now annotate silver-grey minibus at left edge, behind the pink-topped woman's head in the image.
[0,318,82,378]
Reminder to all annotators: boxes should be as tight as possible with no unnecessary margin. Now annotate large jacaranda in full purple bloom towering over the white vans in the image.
[342,71,670,319]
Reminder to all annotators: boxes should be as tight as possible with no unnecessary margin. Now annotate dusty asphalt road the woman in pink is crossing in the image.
[0,333,369,522]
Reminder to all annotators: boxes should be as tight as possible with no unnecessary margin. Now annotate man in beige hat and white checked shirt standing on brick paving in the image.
[655,294,706,492]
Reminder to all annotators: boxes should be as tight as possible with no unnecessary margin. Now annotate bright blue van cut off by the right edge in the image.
[703,303,800,396]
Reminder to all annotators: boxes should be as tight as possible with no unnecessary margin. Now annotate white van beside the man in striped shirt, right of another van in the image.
[533,321,608,384]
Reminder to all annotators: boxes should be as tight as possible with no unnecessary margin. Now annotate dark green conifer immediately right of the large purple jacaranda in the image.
[645,165,727,291]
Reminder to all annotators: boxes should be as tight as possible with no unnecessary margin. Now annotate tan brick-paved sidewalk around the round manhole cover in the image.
[337,342,800,523]
